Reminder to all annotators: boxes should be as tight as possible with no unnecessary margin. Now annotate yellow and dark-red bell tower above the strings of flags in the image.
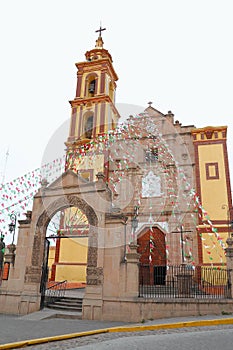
[66,26,119,150]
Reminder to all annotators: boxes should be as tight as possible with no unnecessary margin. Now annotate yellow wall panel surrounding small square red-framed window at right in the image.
[198,144,228,220]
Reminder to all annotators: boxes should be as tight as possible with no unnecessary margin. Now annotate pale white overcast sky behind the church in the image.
[0,0,233,185]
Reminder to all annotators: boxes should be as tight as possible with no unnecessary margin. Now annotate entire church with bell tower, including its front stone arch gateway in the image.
[0,28,232,320]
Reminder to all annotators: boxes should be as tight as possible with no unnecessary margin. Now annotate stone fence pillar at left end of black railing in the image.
[125,242,140,297]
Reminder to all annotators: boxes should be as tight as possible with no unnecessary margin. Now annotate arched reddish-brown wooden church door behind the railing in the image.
[137,227,167,285]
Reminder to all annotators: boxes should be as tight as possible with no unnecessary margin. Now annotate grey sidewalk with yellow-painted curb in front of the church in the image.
[0,308,233,348]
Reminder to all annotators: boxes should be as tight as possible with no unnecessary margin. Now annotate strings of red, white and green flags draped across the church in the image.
[0,115,225,264]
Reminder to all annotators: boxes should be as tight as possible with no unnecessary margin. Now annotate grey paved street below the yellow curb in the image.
[27,325,233,350]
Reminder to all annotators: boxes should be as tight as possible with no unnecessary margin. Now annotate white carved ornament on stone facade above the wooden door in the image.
[142,170,162,197]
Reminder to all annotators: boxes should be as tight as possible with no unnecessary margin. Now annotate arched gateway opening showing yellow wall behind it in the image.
[40,207,89,306]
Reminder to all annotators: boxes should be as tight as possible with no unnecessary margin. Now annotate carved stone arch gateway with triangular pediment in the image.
[0,170,113,314]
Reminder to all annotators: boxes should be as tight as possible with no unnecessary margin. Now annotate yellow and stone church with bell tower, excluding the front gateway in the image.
[48,26,231,285]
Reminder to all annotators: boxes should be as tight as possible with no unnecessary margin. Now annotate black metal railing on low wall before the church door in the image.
[139,264,232,299]
